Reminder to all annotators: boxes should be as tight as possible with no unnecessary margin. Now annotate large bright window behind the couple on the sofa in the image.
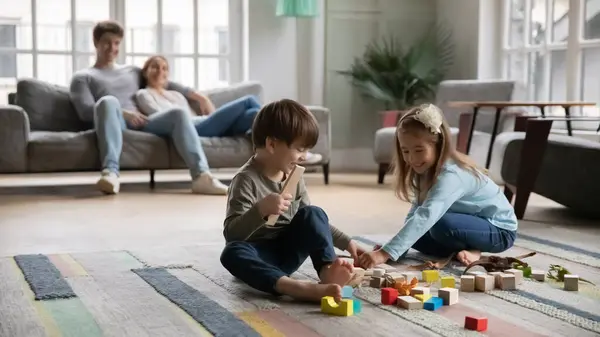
[0,0,242,104]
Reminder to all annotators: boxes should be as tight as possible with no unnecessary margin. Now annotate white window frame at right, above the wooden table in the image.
[501,0,600,130]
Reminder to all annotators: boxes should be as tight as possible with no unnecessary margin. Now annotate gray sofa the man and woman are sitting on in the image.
[0,79,331,186]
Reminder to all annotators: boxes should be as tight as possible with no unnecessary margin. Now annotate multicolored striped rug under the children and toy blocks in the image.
[0,236,600,337]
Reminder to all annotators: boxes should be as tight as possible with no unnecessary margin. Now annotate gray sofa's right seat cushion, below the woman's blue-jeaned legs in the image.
[169,137,253,169]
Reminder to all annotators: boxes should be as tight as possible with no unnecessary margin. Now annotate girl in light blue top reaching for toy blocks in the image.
[359,104,517,268]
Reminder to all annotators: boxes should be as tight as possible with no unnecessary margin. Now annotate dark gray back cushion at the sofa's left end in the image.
[15,79,90,132]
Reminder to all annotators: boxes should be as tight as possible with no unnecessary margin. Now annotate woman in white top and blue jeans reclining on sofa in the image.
[136,55,322,164]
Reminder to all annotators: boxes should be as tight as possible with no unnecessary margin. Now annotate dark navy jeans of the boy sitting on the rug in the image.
[221,206,337,295]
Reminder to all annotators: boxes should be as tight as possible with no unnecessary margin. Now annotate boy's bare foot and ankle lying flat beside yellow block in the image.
[275,276,342,302]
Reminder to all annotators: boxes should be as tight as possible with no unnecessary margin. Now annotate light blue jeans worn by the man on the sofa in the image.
[94,96,209,179]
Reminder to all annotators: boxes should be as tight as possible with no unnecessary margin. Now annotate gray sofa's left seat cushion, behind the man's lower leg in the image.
[28,130,169,172]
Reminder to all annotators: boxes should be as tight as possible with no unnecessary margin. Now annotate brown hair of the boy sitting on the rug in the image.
[252,99,319,149]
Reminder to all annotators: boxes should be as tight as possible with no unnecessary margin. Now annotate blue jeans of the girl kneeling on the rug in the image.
[405,213,517,257]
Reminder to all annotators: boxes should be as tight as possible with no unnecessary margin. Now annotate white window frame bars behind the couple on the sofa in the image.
[0,0,247,88]
